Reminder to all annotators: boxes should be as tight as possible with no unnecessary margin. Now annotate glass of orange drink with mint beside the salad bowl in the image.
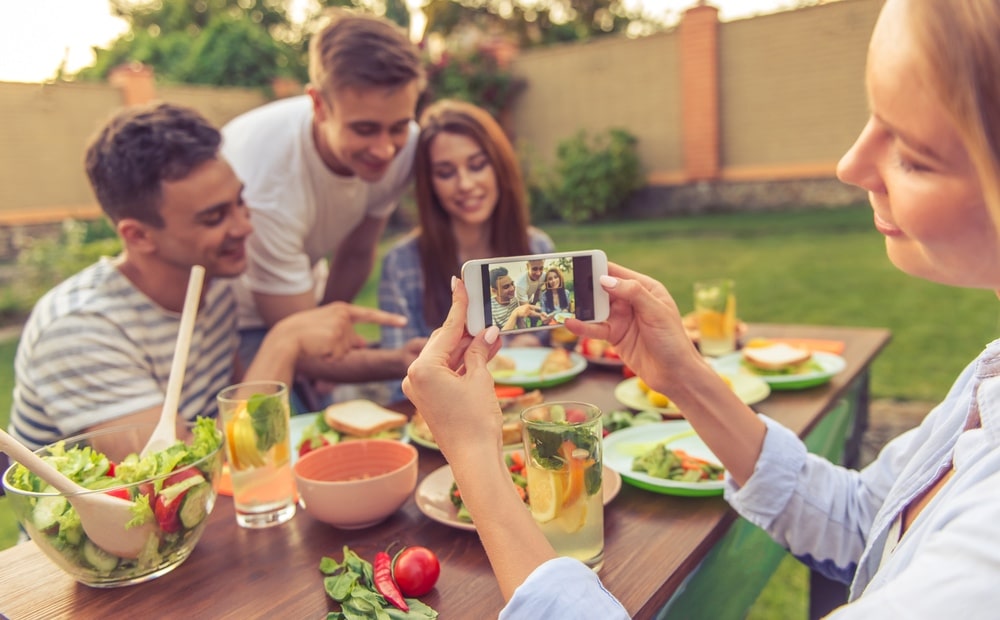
[218,381,295,528]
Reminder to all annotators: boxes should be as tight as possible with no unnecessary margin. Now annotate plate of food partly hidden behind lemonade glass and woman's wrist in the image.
[413,450,622,532]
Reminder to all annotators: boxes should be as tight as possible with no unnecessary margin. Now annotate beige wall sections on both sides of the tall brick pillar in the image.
[513,0,882,185]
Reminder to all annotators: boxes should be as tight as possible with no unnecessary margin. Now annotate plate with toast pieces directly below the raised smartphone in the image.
[489,347,587,390]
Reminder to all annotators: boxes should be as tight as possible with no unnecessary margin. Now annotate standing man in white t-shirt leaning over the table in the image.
[222,13,424,398]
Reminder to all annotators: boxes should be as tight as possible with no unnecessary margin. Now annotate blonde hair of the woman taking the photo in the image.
[907,0,1000,226]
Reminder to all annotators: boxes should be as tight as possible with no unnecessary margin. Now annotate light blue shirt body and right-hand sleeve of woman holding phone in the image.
[726,341,1000,620]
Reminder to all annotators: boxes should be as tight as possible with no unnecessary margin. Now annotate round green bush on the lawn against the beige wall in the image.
[547,129,644,223]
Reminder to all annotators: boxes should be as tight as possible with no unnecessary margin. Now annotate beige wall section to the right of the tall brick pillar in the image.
[719,0,881,176]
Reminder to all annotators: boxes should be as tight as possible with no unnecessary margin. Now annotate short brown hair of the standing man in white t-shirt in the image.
[309,9,425,103]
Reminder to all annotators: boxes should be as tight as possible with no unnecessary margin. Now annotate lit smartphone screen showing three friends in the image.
[480,255,595,331]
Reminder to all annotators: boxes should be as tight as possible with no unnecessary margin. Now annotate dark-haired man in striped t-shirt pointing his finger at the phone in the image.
[10,104,400,447]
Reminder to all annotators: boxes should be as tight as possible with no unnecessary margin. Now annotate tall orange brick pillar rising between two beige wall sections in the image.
[678,3,721,181]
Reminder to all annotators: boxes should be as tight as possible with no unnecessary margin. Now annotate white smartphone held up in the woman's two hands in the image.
[462,250,610,334]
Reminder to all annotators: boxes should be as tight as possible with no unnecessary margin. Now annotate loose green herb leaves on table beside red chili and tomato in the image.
[319,546,438,620]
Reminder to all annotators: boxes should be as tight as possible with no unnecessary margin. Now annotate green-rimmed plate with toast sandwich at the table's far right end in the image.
[712,343,847,390]
